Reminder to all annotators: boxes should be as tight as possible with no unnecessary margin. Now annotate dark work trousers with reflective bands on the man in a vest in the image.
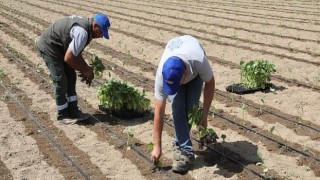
[40,51,78,120]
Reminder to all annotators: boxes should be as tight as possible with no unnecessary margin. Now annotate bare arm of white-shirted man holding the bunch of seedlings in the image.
[201,76,215,127]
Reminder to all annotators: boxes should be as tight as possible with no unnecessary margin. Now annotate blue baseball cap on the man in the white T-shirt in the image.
[162,56,184,95]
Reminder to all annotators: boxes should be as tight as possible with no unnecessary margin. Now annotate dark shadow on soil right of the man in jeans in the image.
[193,141,262,178]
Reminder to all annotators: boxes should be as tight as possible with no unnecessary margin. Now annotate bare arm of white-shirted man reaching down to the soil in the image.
[151,99,166,164]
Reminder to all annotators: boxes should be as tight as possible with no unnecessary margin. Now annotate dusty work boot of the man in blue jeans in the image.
[172,145,195,173]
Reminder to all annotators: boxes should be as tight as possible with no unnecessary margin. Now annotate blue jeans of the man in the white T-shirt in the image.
[168,75,203,153]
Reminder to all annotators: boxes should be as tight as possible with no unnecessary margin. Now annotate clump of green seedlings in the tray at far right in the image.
[240,60,276,89]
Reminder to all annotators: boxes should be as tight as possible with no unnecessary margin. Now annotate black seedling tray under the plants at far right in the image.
[226,83,272,95]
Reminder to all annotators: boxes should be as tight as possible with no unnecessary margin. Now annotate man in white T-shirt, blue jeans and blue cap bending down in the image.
[151,35,215,173]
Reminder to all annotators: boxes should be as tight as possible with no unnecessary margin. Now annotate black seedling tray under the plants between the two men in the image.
[99,105,146,120]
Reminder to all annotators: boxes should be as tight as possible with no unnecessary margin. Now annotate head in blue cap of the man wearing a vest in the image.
[93,13,110,39]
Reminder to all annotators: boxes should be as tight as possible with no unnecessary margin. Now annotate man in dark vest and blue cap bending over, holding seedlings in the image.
[37,13,110,124]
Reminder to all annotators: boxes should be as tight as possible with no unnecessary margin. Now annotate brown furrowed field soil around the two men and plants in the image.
[0,0,320,179]
